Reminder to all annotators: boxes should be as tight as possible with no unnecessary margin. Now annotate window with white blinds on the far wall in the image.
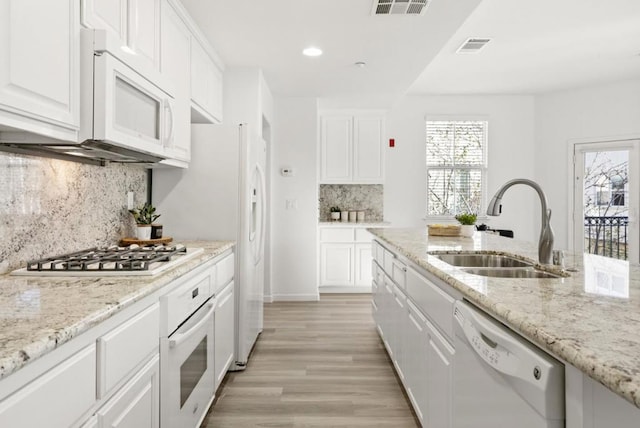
[426,120,488,216]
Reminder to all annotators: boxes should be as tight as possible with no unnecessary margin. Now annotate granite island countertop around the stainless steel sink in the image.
[369,228,640,407]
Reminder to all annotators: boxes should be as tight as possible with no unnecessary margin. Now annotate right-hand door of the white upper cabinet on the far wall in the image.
[353,117,384,183]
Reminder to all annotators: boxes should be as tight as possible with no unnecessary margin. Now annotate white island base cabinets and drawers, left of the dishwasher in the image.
[372,242,459,428]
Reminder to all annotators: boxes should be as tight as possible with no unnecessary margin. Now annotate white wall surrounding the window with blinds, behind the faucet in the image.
[384,95,540,241]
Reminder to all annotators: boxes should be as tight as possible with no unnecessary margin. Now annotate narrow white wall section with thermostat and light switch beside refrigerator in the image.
[271,98,319,300]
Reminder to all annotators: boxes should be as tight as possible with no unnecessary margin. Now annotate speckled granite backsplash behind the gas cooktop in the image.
[0,153,147,273]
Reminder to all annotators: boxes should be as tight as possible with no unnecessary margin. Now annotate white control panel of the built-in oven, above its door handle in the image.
[160,265,215,336]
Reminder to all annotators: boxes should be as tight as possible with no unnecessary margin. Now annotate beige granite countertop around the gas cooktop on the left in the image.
[0,241,234,379]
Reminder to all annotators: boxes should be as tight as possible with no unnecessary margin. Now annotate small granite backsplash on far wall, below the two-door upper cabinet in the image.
[318,184,384,222]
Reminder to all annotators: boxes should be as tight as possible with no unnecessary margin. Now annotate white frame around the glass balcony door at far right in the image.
[567,134,640,263]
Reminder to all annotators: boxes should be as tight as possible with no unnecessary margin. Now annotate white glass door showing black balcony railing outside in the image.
[573,140,640,263]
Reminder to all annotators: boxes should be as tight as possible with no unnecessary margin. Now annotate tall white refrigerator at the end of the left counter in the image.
[152,124,267,370]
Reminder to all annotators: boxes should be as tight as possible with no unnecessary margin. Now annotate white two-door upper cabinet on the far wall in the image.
[320,114,384,183]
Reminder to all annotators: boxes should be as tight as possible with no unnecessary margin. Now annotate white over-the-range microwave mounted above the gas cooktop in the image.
[80,30,174,161]
